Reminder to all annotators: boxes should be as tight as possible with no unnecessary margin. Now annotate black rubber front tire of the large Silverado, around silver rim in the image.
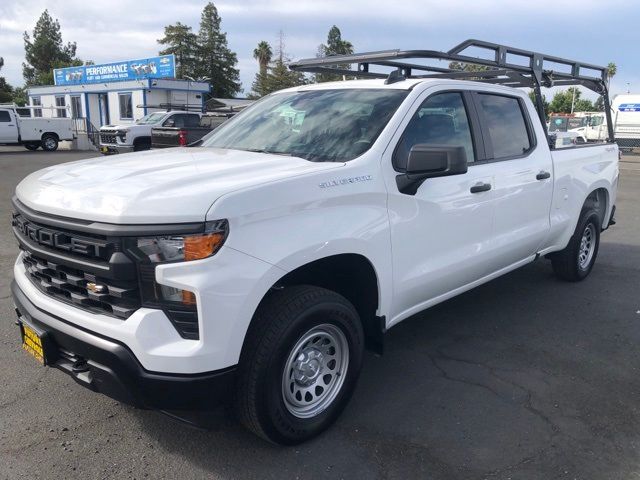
[235,285,364,445]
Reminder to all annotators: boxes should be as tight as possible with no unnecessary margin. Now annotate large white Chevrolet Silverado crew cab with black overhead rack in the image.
[12,39,618,444]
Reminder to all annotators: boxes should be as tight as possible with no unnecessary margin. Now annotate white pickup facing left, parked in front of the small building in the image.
[100,110,201,155]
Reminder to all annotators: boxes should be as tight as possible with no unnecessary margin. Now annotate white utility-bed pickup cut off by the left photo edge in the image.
[0,106,75,152]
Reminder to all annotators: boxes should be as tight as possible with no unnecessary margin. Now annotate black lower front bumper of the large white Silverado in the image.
[11,281,236,410]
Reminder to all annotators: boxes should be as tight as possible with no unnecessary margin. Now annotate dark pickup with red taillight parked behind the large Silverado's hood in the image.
[151,112,234,148]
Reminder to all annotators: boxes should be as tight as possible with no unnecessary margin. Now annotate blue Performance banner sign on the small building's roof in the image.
[53,55,176,85]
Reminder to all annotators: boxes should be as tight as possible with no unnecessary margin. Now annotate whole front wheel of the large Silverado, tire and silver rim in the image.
[236,286,364,445]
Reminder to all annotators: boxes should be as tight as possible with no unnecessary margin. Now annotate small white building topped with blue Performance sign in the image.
[27,55,211,129]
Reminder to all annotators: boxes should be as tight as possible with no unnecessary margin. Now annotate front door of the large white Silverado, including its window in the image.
[383,91,494,324]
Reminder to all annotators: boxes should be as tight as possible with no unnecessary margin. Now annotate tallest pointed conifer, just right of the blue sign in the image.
[195,2,241,98]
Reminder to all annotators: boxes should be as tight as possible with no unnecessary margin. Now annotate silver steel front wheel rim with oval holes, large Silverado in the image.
[282,324,349,418]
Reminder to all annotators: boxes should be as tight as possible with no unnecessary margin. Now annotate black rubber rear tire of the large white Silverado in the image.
[550,208,602,282]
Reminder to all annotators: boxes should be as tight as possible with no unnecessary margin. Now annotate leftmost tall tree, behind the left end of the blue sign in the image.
[22,10,82,85]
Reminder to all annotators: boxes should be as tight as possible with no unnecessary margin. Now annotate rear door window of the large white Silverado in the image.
[478,93,531,159]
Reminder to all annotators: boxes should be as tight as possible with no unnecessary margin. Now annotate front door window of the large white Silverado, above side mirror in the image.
[393,92,476,171]
